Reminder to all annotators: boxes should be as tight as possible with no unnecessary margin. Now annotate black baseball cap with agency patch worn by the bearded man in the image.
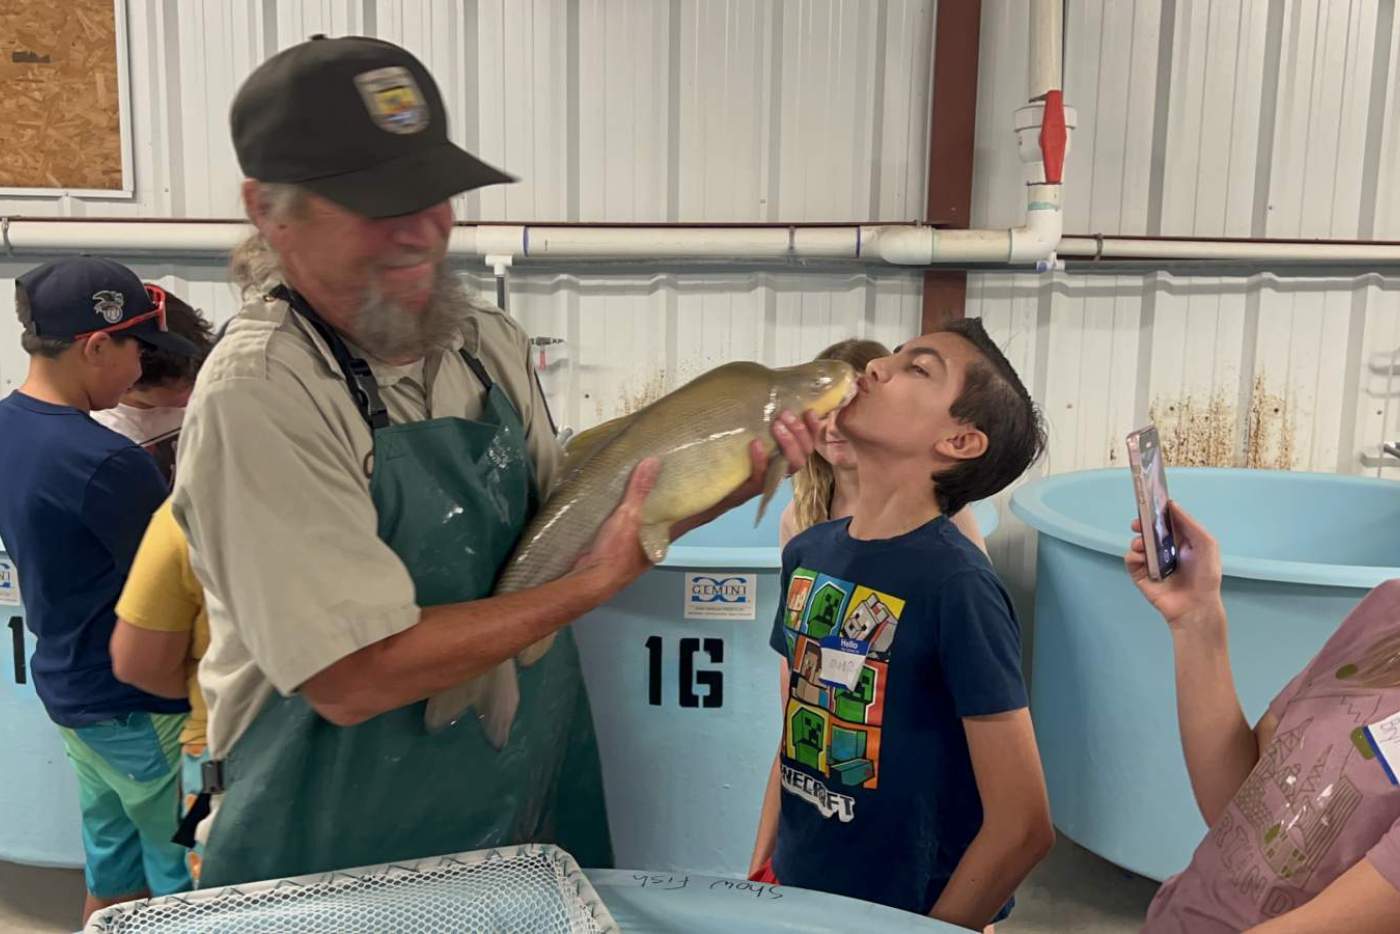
[230,35,517,217]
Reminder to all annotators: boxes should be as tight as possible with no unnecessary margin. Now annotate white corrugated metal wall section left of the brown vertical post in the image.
[0,0,932,426]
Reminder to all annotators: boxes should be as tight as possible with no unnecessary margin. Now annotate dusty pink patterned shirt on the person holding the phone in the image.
[1144,580,1400,934]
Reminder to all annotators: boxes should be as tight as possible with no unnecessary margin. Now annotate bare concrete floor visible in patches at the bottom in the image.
[0,840,1156,934]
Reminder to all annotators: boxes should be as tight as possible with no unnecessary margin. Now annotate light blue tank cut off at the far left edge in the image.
[0,552,83,867]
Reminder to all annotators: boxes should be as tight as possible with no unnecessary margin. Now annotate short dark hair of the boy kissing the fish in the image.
[932,318,1046,515]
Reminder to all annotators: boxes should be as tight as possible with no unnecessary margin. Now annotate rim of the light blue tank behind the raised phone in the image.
[1011,468,1400,590]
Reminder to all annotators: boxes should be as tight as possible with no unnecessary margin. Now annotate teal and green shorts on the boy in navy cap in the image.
[59,713,190,899]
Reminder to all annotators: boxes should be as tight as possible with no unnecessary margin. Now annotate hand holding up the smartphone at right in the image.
[1123,501,1225,632]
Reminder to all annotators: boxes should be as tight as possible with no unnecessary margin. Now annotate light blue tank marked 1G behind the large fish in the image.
[574,483,997,877]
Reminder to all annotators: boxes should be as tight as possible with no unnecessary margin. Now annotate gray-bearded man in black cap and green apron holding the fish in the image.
[174,36,815,886]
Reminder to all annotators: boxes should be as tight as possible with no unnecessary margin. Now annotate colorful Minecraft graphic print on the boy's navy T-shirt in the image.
[783,567,904,821]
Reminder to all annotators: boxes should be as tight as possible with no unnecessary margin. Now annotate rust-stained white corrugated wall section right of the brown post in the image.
[969,0,1400,613]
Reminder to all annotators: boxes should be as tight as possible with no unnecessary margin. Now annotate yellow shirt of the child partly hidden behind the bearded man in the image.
[116,500,209,752]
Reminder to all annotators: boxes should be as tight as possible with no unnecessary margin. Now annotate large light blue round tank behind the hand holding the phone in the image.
[1012,468,1400,879]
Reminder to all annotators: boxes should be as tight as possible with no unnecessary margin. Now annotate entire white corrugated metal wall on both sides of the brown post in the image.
[0,0,1400,616]
